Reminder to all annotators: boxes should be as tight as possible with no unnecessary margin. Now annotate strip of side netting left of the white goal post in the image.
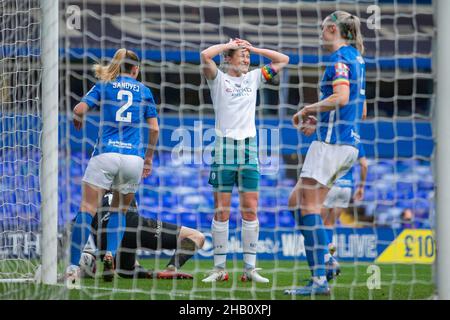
[0,1,41,284]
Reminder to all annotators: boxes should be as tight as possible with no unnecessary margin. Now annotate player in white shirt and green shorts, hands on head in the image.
[201,39,289,283]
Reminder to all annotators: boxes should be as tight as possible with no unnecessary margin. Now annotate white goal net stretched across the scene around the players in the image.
[0,0,435,299]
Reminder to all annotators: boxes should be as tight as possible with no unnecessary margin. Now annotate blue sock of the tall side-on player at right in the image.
[302,214,328,277]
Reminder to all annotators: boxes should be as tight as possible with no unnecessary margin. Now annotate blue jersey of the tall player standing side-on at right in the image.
[317,46,366,146]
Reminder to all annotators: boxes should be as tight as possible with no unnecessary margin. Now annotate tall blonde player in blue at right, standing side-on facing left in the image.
[285,11,365,295]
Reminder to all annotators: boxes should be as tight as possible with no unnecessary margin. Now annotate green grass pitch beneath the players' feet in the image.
[0,259,435,300]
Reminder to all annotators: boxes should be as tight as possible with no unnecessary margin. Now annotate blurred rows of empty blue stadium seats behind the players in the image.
[0,153,434,229]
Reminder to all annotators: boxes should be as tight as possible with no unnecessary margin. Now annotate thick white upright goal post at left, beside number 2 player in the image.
[40,0,59,284]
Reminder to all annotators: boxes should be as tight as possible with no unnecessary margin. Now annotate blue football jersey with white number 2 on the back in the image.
[81,76,157,158]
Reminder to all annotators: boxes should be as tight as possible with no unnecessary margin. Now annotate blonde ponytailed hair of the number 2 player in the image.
[93,48,139,81]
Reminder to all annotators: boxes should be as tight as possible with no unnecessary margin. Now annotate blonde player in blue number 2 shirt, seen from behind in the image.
[66,48,159,283]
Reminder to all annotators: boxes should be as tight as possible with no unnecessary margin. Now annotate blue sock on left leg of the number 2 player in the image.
[70,212,92,266]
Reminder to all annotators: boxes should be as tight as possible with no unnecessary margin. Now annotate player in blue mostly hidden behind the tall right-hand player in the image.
[321,143,368,280]
